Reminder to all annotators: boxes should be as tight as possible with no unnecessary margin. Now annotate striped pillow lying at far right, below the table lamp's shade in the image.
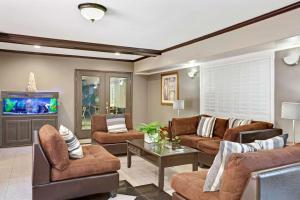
[254,134,287,150]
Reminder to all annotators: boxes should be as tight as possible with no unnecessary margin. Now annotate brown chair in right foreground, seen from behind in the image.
[171,144,300,200]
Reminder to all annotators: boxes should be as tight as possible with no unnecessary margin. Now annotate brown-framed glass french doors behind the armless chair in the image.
[75,70,132,138]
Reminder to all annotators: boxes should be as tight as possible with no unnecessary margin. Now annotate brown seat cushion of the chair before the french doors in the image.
[93,130,144,144]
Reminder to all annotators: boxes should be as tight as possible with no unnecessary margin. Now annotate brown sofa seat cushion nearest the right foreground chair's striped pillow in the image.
[196,138,221,155]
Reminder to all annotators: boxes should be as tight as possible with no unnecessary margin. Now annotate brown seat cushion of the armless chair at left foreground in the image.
[51,145,120,181]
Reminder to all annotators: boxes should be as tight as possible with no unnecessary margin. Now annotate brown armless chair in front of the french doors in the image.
[91,114,144,155]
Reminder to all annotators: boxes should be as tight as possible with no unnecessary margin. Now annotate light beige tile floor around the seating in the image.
[0,146,201,200]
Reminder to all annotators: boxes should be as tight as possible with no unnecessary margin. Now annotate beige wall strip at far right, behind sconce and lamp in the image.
[275,48,300,142]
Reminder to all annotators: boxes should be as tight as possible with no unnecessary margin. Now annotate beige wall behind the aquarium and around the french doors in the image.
[0,52,146,130]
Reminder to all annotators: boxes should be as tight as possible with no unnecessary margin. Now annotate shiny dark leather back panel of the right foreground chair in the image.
[242,162,300,200]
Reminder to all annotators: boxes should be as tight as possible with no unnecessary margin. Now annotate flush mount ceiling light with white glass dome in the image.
[78,3,107,22]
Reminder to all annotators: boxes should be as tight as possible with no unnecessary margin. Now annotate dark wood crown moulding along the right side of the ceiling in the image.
[134,1,300,62]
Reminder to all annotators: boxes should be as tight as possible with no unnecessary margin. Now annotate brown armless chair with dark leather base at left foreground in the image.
[32,125,120,200]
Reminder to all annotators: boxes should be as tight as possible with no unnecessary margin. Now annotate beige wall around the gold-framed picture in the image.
[148,69,200,124]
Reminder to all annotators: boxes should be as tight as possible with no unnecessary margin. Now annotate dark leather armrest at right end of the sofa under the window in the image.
[238,128,282,143]
